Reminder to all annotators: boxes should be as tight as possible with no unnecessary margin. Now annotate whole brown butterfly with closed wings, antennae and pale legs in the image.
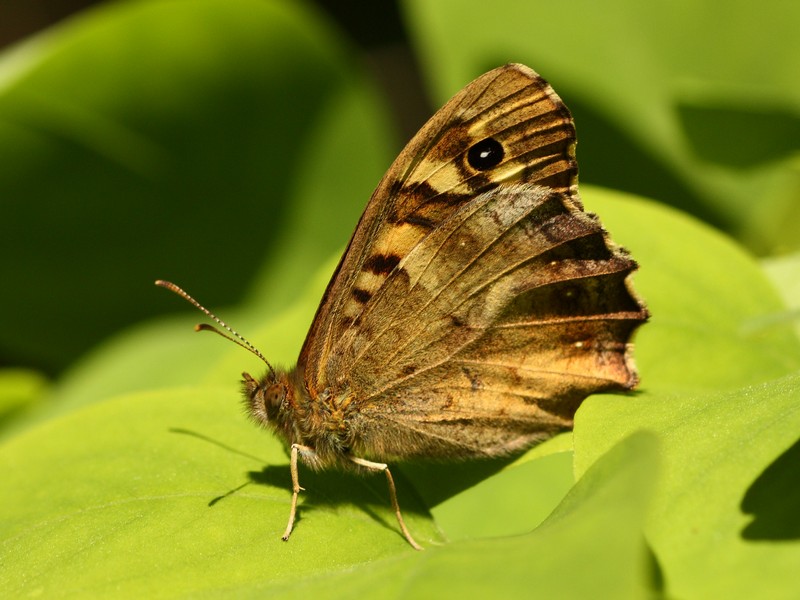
[157,64,648,549]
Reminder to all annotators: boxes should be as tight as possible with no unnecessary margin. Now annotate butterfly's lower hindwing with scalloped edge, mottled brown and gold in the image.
[346,184,647,457]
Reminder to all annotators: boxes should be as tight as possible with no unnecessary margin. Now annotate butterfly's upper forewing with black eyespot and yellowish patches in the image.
[297,65,580,398]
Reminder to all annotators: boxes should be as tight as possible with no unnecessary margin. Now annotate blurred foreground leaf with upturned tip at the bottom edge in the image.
[298,433,658,598]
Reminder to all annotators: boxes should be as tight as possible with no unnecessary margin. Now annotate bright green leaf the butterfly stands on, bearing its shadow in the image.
[0,385,438,597]
